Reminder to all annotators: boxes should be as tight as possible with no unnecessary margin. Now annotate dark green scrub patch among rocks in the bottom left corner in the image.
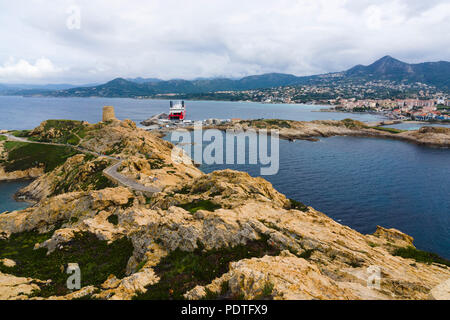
[0,232,133,297]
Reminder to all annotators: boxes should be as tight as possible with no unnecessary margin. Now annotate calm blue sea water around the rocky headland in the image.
[0,97,450,258]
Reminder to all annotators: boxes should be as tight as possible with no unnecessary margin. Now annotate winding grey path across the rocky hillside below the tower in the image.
[0,133,162,196]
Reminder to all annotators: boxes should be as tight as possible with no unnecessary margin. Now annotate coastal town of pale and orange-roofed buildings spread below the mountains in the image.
[149,81,450,122]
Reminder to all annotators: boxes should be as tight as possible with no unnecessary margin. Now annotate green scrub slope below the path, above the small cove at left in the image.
[3,141,79,172]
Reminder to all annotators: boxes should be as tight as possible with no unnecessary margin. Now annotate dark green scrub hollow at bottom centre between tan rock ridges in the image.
[136,237,280,300]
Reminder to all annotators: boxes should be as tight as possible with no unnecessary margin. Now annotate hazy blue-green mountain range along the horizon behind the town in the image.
[0,56,450,98]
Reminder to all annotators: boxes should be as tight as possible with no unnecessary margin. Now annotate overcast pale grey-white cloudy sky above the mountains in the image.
[0,0,450,84]
